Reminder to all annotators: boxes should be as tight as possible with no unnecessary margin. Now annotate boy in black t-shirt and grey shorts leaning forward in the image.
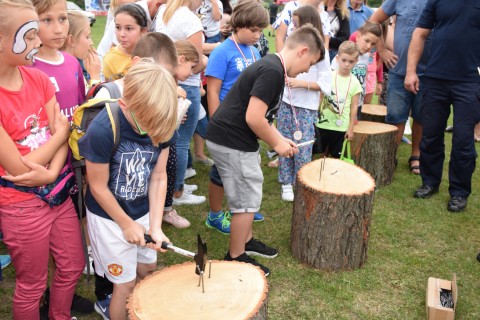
[207,26,325,275]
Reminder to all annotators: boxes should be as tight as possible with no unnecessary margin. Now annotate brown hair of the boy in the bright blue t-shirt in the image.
[230,1,270,31]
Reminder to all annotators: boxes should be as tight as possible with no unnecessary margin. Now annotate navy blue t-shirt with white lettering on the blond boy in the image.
[78,109,168,220]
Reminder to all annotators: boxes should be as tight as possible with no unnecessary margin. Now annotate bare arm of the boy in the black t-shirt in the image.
[245,96,298,157]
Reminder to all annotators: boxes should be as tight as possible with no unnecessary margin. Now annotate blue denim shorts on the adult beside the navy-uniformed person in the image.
[385,72,423,124]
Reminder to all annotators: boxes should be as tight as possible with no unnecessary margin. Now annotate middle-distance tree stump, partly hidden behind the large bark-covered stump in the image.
[351,121,398,186]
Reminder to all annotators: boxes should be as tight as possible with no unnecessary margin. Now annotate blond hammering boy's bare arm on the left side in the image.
[86,160,145,246]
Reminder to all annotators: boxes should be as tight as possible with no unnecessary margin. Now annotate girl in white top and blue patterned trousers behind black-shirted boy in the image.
[277,5,331,201]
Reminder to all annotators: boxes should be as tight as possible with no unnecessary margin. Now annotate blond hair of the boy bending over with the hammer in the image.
[123,58,178,145]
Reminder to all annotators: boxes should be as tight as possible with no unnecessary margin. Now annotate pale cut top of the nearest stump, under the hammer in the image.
[127,260,268,320]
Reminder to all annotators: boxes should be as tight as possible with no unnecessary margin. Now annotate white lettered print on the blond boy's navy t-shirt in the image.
[111,141,154,200]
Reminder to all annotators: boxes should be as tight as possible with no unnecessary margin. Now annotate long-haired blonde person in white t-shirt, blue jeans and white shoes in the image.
[155,0,206,204]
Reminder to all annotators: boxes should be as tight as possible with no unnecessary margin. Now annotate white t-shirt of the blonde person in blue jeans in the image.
[155,5,203,87]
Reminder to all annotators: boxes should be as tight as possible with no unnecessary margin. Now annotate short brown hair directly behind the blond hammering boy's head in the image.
[132,32,178,67]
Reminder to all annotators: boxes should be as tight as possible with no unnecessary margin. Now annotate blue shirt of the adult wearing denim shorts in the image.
[382,0,432,77]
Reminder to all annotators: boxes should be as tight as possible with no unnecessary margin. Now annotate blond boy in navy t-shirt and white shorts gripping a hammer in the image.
[79,59,177,319]
